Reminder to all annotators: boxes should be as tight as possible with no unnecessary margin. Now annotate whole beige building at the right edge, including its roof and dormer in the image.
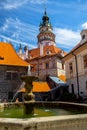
[63,30,87,96]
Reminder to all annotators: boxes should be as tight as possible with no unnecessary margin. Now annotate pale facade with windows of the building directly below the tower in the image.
[29,54,65,80]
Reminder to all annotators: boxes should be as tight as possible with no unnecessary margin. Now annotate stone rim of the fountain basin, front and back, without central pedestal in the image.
[0,102,87,130]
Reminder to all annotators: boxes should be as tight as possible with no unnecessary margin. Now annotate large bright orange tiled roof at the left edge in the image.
[0,42,29,66]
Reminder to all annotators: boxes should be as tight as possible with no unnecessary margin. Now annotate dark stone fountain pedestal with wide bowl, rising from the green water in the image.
[21,75,38,114]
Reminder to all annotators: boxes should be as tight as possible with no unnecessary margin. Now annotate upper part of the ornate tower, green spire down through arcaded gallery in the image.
[37,10,55,48]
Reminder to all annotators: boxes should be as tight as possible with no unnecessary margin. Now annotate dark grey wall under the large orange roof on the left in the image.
[0,66,27,102]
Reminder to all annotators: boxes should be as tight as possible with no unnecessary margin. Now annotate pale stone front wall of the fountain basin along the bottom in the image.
[0,114,87,130]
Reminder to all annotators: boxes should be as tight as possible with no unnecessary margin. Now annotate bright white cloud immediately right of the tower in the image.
[54,28,80,50]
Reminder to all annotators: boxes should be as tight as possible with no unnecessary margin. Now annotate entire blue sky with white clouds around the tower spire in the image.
[0,0,87,52]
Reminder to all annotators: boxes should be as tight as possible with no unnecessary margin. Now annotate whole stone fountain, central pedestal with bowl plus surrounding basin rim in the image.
[0,75,87,130]
